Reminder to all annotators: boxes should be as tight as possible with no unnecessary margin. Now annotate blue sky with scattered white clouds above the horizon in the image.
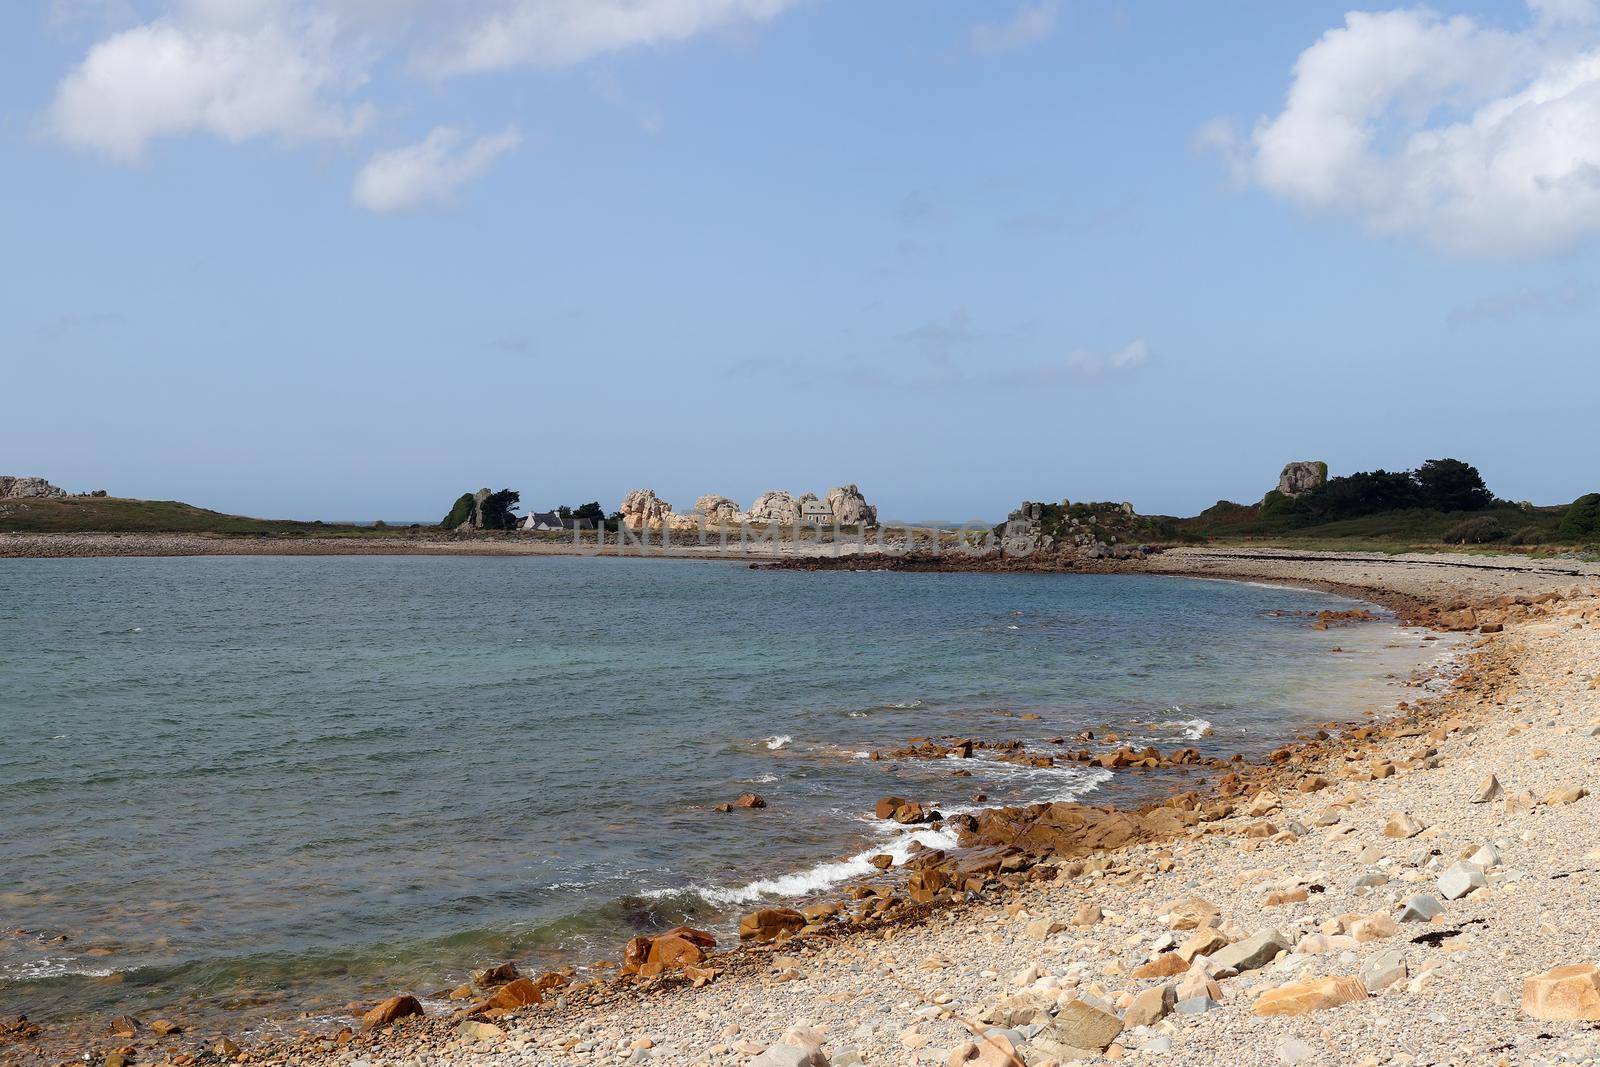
[0,0,1600,520]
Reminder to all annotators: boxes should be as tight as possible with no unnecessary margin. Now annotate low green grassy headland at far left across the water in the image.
[0,496,419,537]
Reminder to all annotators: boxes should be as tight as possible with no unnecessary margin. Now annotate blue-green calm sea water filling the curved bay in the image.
[0,558,1429,1036]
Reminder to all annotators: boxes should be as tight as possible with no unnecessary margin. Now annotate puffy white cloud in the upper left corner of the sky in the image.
[46,0,370,162]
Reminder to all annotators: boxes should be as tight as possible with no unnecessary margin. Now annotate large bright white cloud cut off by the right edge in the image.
[1222,0,1600,254]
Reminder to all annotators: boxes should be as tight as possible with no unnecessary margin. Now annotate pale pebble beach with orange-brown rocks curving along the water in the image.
[0,553,1600,1067]
